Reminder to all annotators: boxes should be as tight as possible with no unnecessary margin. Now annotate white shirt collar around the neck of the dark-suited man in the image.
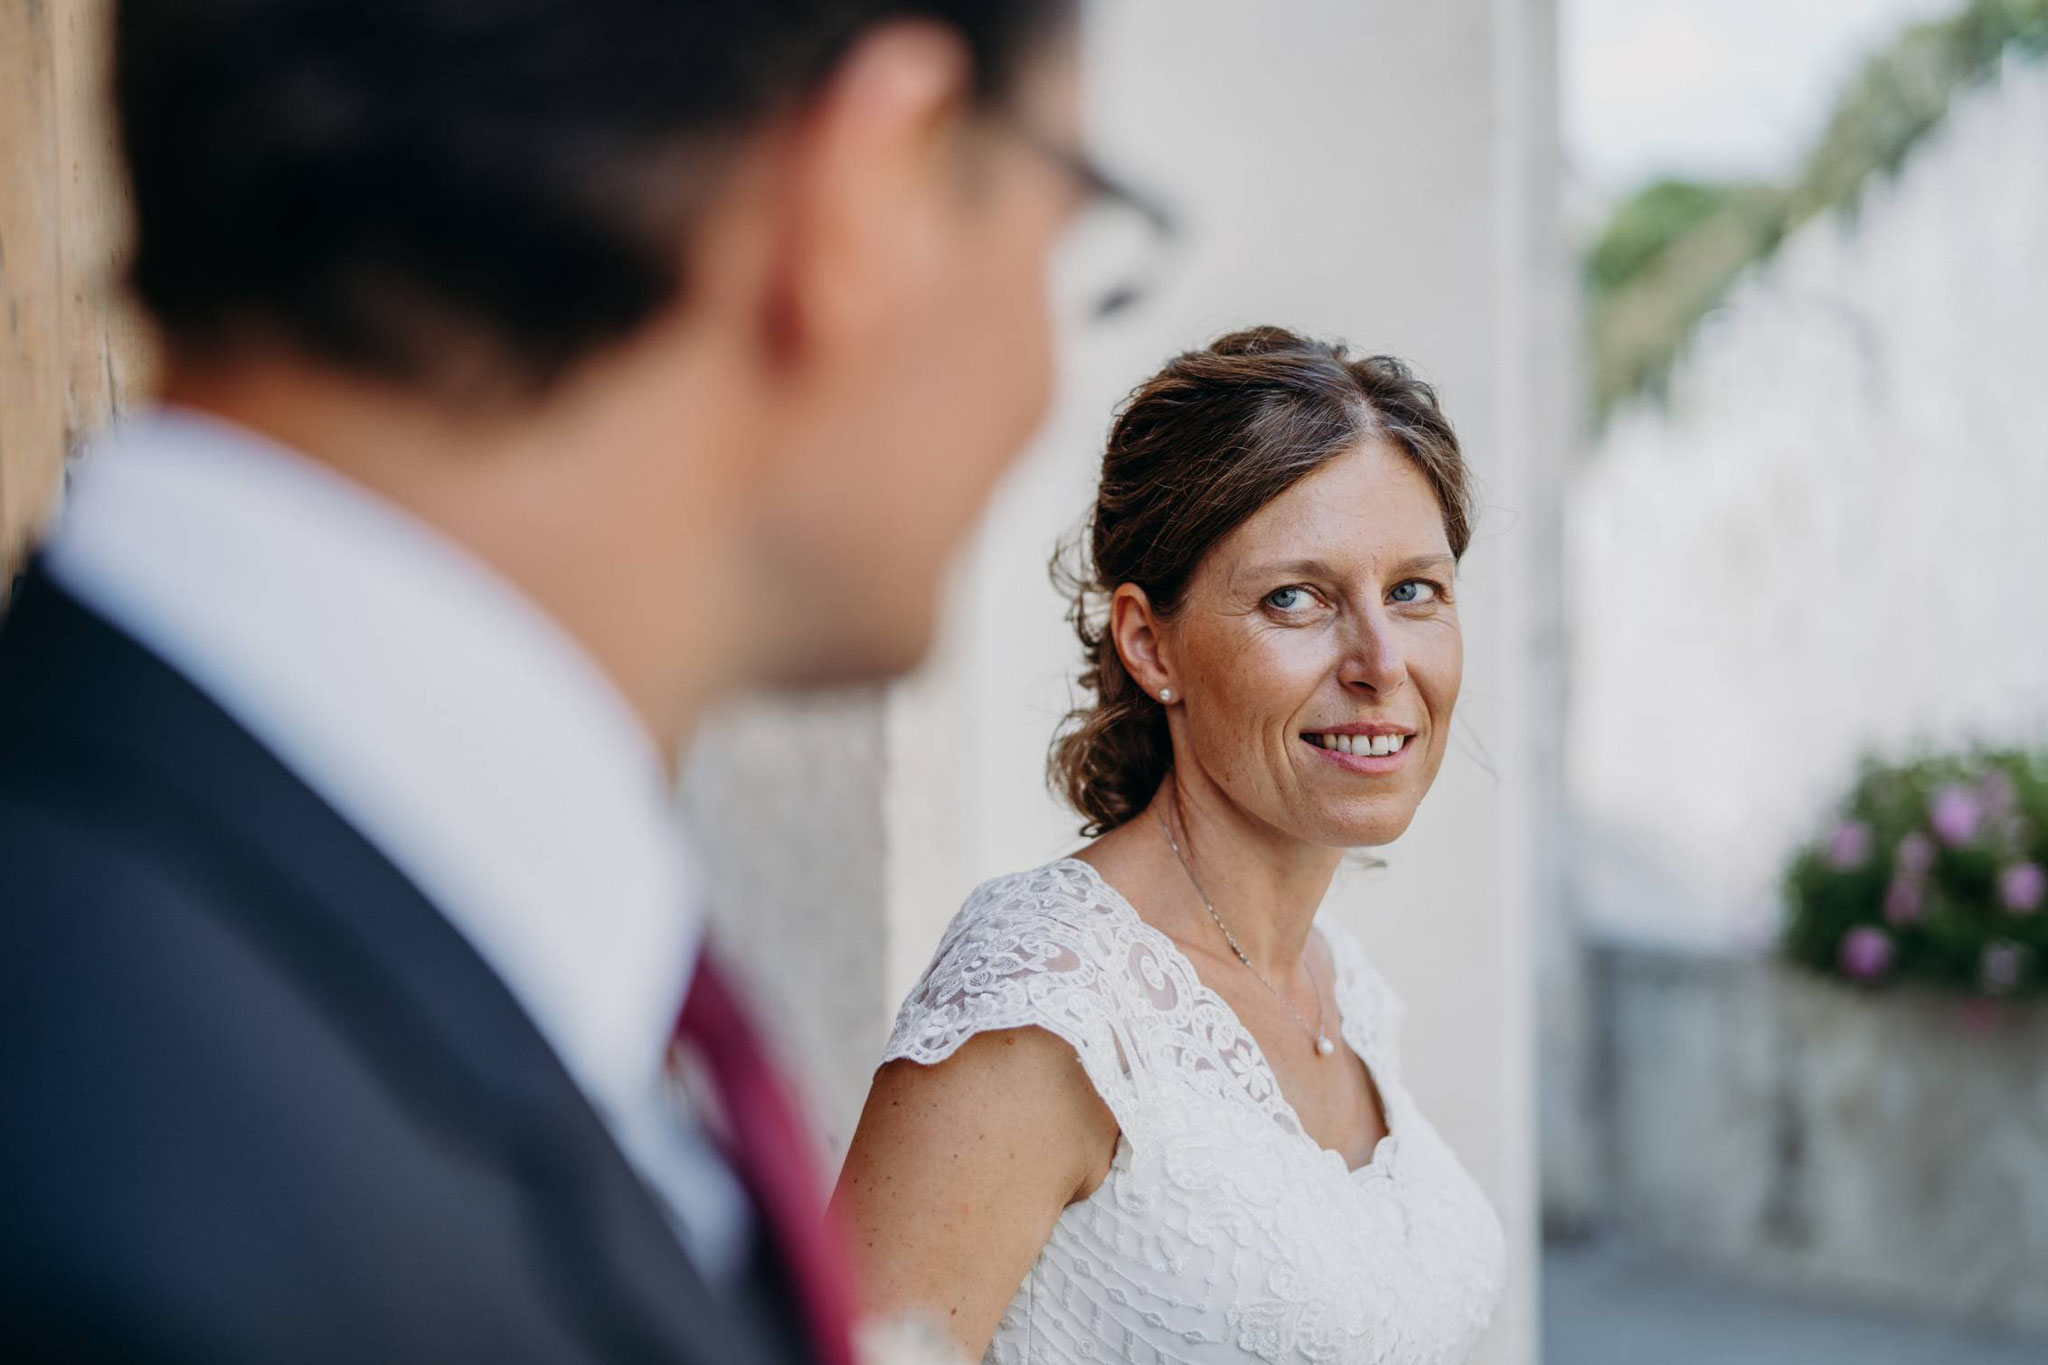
[45,411,702,1126]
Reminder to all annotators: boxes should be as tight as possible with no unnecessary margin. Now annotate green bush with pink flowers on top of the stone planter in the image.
[1784,749,2048,995]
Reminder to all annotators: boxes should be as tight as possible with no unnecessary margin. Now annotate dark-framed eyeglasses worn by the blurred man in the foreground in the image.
[1006,121,1180,321]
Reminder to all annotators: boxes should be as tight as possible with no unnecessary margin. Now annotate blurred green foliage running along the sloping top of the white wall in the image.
[1585,0,2048,413]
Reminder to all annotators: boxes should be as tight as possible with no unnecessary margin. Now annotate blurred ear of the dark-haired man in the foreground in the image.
[770,20,973,364]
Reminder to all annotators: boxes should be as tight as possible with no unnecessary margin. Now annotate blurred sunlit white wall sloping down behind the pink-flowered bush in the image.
[1571,65,2048,941]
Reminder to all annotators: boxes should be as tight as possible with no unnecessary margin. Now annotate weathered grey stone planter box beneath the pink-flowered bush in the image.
[1593,943,2048,1336]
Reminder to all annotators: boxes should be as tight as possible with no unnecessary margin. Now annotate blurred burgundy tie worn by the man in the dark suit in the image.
[674,952,854,1365]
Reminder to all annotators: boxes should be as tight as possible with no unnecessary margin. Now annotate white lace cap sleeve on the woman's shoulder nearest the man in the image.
[883,870,1139,1138]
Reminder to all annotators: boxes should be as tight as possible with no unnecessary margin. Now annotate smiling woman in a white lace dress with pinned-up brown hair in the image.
[840,327,1503,1365]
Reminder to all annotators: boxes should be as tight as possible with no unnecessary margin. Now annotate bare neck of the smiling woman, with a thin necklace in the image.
[1141,772,1343,980]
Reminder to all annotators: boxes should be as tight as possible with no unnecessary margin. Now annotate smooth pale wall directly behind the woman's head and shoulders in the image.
[690,0,1569,1365]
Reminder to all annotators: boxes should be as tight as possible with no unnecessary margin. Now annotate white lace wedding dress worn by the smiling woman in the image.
[887,857,1503,1365]
